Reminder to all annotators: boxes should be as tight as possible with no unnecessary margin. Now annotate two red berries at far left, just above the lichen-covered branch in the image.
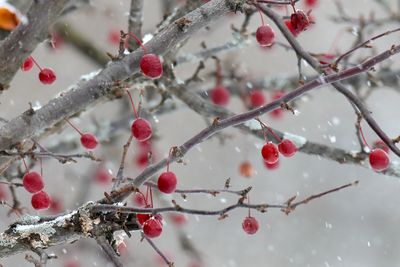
[22,160,50,210]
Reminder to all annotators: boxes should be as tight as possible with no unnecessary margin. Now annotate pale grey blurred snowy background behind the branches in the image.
[0,0,400,267]
